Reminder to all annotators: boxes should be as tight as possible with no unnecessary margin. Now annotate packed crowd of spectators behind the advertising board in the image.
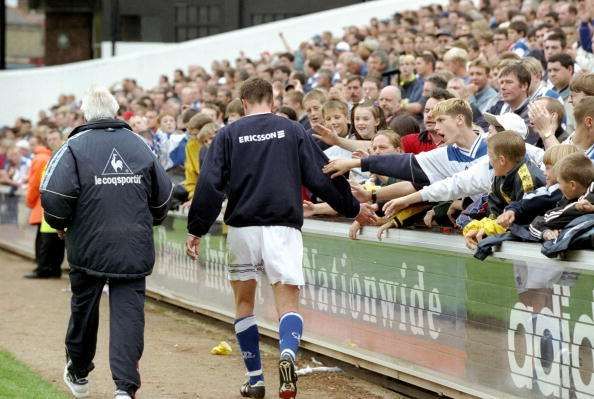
[0,0,594,255]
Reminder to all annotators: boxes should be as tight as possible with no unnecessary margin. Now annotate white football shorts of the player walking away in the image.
[227,226,305,286]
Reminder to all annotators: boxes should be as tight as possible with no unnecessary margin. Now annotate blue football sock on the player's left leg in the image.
[235,316,264,385]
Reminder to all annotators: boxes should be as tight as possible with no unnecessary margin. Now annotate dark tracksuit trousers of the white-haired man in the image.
[66,269,146,395]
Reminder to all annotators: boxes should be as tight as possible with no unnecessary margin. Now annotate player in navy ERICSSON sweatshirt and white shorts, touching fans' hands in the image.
[186,78,365,398]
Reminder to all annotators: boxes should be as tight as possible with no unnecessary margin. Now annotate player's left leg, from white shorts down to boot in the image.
[227,227,265,398]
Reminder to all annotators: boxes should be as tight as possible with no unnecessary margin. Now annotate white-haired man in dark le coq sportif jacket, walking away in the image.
[41,89,173,399]
